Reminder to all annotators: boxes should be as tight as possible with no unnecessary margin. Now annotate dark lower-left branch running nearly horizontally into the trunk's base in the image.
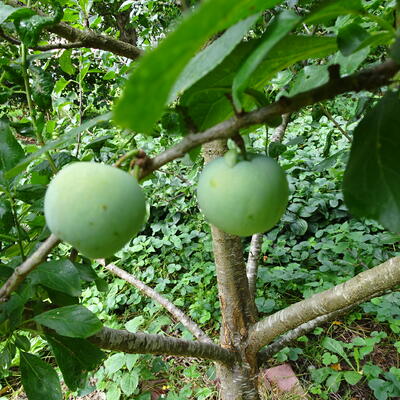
[89,328,237,364]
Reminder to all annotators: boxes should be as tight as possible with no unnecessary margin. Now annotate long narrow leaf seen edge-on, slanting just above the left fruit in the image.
[5,112,111,178]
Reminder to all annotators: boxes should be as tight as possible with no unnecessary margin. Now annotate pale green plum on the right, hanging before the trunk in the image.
[197,155,289,236]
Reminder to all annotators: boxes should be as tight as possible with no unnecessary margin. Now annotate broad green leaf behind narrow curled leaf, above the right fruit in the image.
[181,35,337,130]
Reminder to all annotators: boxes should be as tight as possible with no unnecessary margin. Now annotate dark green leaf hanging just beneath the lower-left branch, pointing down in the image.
[46,335,105,391]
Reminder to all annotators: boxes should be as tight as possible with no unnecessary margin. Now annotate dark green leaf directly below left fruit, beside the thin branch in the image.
[29,259,81,297]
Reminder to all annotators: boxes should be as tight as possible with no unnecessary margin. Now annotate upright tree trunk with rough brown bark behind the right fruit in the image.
[203,140,259,400]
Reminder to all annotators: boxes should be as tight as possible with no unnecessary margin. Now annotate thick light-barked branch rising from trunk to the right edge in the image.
[248,257,400,352]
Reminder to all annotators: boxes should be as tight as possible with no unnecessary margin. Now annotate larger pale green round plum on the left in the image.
[44,162,146,258]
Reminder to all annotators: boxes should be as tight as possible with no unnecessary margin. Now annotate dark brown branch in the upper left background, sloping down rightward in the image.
[4,0,143,60]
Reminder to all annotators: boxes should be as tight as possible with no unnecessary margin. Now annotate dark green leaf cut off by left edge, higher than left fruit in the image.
[0,121,25,172]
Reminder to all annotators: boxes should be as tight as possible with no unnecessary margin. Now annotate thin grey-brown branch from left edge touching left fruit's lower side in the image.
[0,235,59,304]
